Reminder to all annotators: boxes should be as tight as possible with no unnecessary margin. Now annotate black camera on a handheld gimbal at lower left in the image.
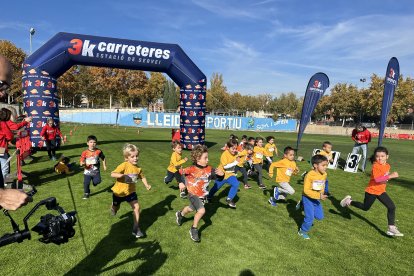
[0,197,76,247]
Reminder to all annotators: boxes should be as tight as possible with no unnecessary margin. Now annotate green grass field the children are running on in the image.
[0,124,414,275]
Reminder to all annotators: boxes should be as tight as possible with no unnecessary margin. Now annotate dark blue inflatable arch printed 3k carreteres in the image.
[22,33,207,149]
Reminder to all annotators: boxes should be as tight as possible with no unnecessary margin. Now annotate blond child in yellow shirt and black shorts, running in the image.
[110,144,151,238]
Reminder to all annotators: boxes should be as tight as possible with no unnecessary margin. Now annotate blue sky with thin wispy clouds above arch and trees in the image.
[0,0,414,96]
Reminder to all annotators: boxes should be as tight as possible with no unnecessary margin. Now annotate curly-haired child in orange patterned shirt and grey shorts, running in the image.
[175,145,224,242]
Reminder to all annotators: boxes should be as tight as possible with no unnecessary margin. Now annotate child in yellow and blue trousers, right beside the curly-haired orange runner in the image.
[208,139,240,208]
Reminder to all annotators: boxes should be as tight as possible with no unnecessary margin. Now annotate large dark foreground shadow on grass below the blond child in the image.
[65,212,168,275]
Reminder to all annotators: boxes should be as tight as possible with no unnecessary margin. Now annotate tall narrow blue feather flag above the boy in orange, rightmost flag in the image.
[378,57,400,146]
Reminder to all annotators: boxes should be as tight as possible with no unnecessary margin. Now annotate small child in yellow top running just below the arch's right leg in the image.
[164,140,188,198]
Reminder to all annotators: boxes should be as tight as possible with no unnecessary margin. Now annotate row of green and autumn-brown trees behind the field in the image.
[0,40,414,122]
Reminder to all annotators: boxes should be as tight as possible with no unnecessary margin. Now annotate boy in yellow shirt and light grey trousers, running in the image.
[268,147,299,206]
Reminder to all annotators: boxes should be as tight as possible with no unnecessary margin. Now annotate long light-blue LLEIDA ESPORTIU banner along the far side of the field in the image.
[60,109,296,132]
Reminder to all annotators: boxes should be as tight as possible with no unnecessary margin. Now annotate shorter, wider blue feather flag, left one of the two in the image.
[296,73,329,149]
